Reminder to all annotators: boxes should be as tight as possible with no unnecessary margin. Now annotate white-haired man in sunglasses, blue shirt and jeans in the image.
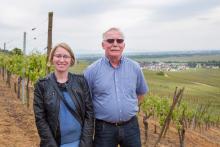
[84,28,148,147]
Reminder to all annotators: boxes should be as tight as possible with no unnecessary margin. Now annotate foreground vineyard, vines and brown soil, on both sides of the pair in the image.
[0,53,220,147]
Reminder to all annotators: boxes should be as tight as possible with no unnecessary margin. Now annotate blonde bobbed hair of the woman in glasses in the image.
[48,42,76,66]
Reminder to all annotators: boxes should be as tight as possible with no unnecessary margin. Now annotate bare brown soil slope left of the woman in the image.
[0,77,39,147]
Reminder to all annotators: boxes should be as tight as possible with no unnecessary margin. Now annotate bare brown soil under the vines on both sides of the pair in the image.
[0,76,220,147]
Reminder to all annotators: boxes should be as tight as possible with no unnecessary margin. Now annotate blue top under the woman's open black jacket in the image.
[59,90,81,147]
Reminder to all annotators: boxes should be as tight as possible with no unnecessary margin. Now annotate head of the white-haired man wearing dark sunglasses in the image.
[102,30,125,59]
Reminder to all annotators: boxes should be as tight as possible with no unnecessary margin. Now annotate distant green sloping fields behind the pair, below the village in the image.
[70,60,220,114]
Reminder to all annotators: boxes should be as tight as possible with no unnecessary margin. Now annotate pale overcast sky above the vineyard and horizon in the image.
[0,0,220,53]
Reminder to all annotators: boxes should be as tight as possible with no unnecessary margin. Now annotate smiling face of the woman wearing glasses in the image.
[53,47,71,72]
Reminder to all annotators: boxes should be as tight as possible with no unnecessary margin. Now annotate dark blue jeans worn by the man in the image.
[94,116,141,147]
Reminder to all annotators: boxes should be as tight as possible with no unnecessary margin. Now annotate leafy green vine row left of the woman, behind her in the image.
[0,50,46,106]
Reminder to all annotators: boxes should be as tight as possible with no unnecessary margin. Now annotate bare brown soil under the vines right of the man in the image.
[139,114,220,147]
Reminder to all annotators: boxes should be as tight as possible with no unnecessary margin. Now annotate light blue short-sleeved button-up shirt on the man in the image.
[84,57,148,122]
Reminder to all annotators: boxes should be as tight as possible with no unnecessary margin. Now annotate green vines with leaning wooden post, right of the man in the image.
[141,88,220,147]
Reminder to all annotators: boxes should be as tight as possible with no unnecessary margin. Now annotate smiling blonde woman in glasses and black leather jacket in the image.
[33,43,94,147]
